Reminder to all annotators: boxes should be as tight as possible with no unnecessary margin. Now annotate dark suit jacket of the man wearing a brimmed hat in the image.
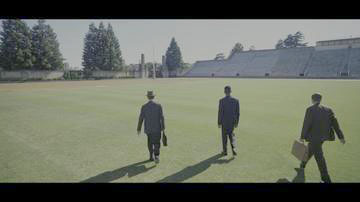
[137,101,165,134]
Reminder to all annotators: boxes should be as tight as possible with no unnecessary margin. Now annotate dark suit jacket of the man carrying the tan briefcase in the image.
[301,104,344,142]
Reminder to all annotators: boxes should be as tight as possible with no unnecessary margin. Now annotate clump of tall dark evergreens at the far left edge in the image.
[0,19,64,70]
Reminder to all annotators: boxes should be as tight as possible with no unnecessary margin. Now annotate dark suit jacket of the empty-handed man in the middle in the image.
[218,96,240,129]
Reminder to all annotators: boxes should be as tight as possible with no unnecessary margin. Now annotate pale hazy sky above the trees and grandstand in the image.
[0,19,360,68]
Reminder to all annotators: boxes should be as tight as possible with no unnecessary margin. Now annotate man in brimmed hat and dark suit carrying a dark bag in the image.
[137,91,165,163]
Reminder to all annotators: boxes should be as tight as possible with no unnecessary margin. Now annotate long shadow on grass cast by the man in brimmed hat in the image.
[81,160,156,183]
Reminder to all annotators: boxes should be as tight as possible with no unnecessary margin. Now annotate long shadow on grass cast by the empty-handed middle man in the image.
[158,154,234,182]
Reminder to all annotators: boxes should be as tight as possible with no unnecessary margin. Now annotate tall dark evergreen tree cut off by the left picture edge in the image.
[0,20,34,70]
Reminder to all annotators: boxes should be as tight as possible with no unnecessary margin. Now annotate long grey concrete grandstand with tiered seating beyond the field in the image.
[183,38,360,78]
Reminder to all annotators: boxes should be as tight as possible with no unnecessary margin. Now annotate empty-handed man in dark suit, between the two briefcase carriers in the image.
[218,86,240,156]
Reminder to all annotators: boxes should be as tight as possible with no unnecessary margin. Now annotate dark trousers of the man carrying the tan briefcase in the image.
[302,141,331,182]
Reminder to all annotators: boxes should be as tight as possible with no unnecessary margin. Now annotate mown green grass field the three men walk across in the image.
[0,78,360,182]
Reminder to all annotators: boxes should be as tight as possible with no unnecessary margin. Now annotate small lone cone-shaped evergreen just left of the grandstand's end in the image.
[166,37,183,71]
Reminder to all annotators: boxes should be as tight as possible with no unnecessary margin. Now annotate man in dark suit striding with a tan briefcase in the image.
[300,93,345,183]
